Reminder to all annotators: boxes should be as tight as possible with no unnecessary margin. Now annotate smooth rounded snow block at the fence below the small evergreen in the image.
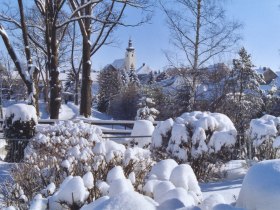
[131,120,155,148]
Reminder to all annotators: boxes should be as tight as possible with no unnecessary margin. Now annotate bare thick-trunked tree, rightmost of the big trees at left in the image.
[68,0,149,117]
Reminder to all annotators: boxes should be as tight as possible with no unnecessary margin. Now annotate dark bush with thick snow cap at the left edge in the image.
[4,104,37,162]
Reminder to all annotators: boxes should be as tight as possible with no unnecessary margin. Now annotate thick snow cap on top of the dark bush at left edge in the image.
[4,104,38,124]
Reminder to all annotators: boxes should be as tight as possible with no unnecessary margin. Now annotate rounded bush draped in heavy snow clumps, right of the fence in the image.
[152,111,237,178]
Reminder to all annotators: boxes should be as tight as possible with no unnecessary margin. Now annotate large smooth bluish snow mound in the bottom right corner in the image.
[236,159,280,210]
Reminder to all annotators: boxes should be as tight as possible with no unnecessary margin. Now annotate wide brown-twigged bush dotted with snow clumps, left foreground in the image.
[1,121,152,209]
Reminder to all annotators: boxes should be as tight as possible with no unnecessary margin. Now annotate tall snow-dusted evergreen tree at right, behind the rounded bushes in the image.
[218,48,264,158]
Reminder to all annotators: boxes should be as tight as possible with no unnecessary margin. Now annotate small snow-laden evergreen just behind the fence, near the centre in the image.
[135,97,159,122]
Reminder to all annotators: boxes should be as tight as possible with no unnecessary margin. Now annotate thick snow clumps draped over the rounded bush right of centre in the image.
[152,111,237,161]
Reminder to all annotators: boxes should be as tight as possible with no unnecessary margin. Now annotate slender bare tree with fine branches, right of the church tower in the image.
[160,0,241,110]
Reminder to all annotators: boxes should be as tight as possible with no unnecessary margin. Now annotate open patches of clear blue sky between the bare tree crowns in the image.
[0,0,280,71]
